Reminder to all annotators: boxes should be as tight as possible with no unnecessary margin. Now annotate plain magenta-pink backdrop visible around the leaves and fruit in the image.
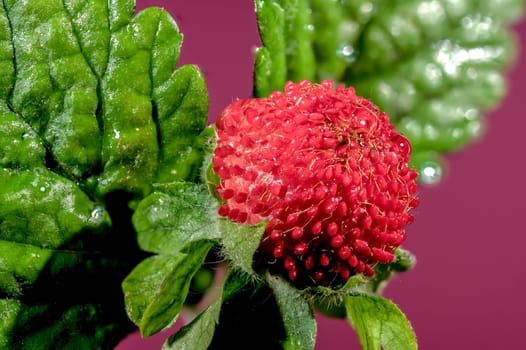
[117,0,526,350]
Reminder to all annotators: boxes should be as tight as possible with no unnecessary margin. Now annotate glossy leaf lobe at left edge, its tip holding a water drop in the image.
[0,168,111,249]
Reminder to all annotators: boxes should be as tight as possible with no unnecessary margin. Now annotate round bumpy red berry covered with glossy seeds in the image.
[213,81,418,286]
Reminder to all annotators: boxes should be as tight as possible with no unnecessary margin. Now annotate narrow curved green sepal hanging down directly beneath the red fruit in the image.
[266,274,316,350]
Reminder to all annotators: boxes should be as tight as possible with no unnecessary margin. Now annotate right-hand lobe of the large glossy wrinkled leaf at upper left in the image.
[96,8,208,196]
